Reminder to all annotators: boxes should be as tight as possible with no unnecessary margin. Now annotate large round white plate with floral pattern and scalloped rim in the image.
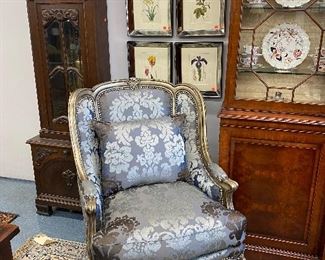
[262,23,310,70]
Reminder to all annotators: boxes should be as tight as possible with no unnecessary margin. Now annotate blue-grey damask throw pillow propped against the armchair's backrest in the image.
[93,115,187,196]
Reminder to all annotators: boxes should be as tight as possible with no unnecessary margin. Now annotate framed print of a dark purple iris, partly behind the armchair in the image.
[175,43,223,98]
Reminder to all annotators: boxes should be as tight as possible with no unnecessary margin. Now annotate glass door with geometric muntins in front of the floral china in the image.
[236,0,325,105]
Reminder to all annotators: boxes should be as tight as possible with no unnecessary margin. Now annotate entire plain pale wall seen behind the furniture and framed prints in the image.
[0,0,226,180]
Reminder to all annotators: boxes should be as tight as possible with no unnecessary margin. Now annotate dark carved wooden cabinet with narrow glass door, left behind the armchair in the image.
[27,0,110,215]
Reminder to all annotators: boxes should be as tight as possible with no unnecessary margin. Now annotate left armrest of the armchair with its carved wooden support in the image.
[80,180,97,259]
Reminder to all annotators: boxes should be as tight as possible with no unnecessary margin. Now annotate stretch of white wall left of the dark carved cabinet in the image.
[0,0,40,180]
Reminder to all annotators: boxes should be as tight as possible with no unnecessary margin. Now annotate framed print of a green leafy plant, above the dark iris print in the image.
[177,0,225,37]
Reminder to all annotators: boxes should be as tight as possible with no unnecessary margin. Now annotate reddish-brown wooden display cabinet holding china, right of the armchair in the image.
[219,0,325,260]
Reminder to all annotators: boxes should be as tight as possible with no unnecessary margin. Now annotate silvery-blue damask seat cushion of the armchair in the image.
[93,181,246,259]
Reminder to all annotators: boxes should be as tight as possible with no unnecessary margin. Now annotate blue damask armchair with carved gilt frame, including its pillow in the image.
[69,79,246,259]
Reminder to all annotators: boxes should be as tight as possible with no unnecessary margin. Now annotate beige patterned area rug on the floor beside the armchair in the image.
[13,235,87,260]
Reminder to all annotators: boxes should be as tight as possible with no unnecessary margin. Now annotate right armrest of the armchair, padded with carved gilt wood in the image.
[208,163,238,209]
